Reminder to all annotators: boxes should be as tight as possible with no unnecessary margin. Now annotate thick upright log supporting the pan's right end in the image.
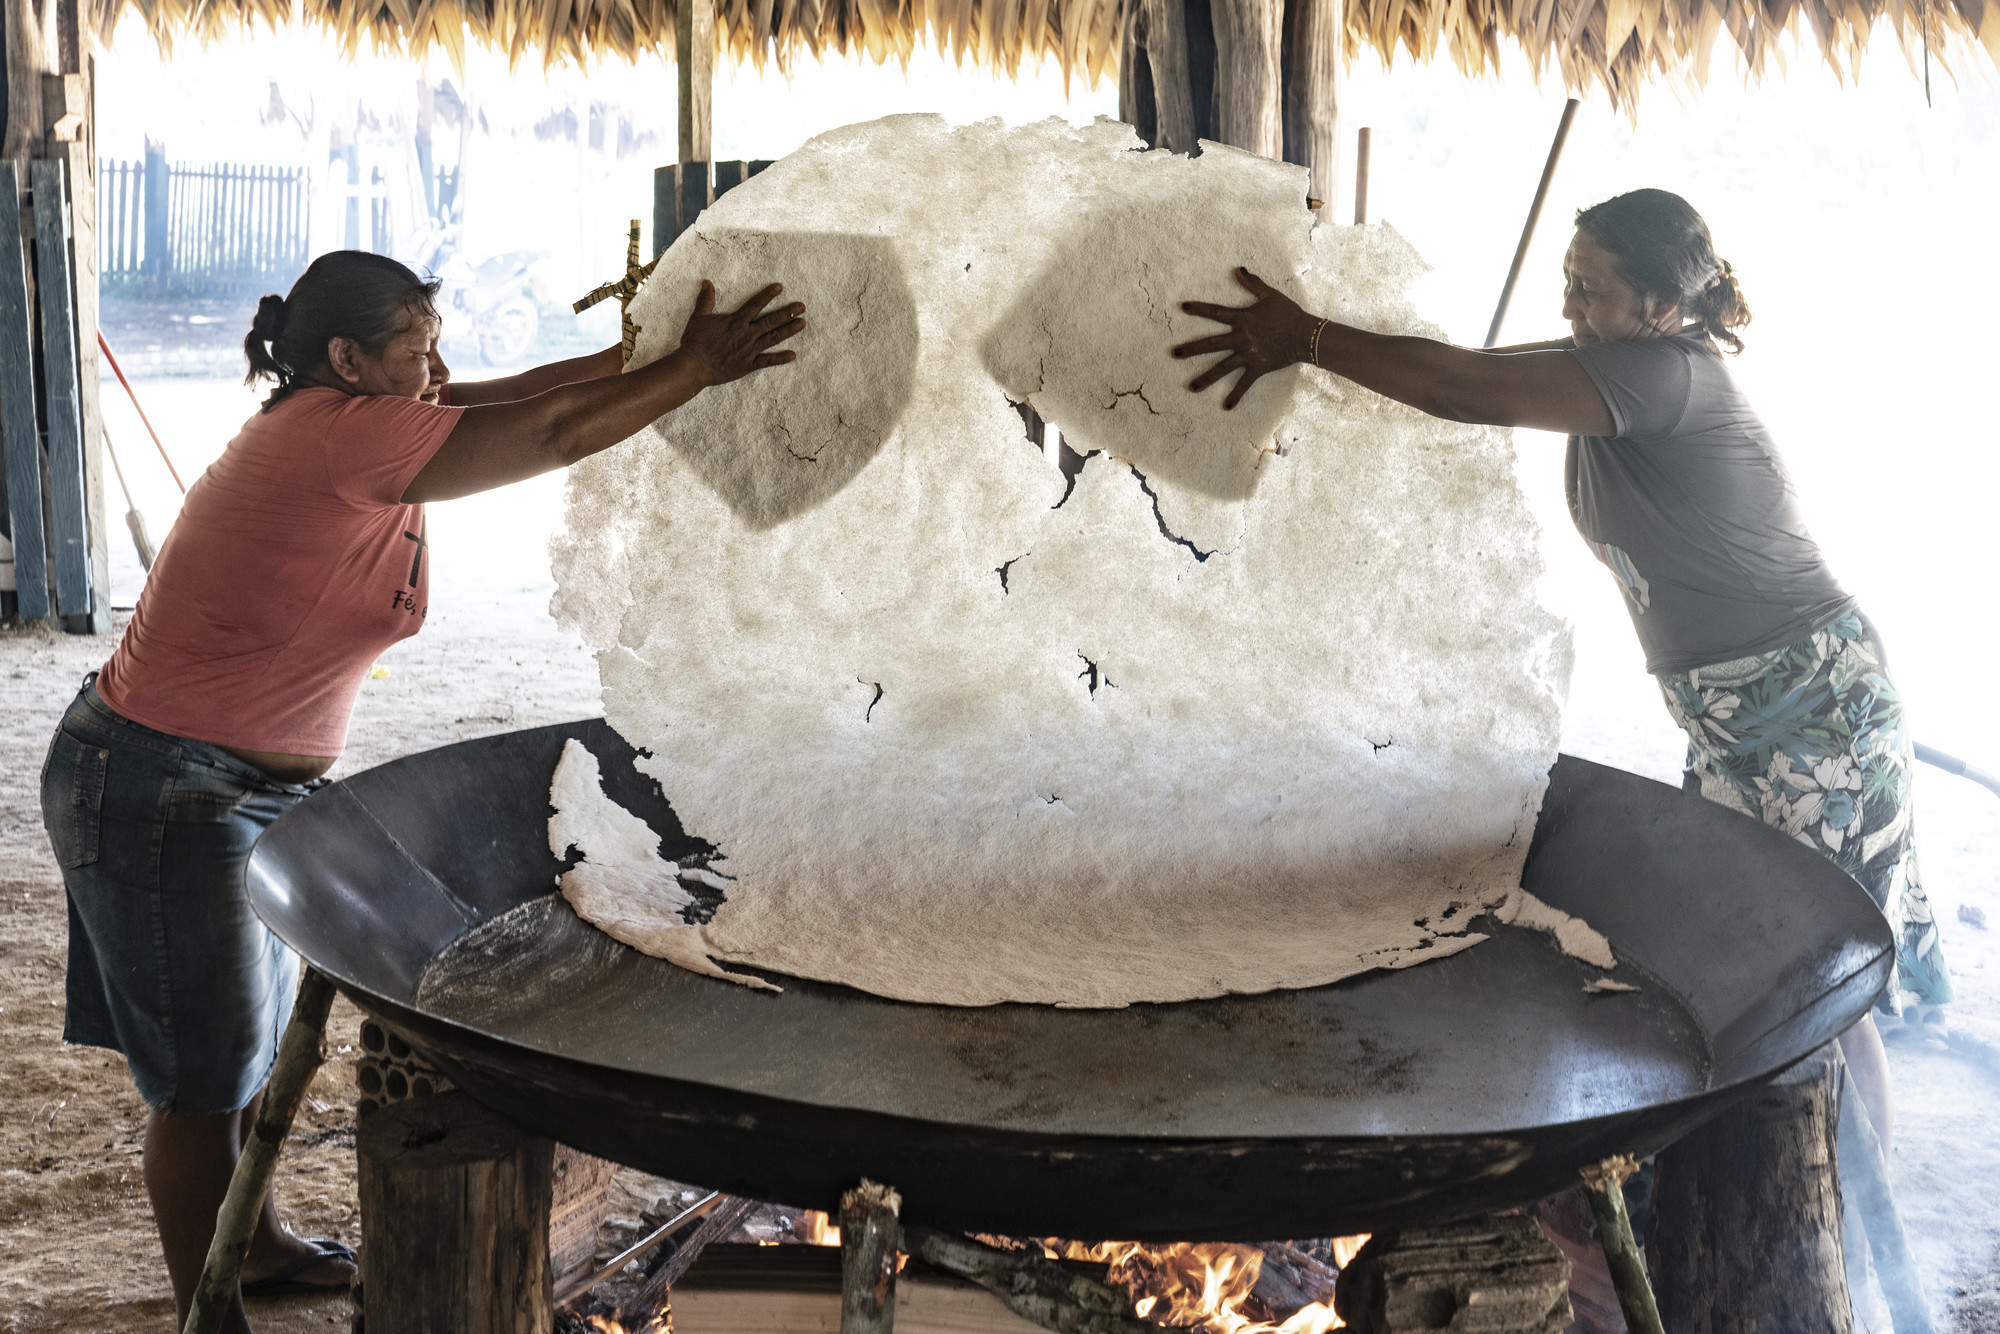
[1648,1050,1852,1334]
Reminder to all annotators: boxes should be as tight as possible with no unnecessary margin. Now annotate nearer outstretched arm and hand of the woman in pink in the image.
[402,280,806,504]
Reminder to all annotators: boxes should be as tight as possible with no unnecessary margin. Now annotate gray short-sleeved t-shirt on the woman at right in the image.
[1564,328,1854,674]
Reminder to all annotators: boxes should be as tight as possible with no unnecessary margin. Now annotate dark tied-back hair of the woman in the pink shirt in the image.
[244,250,440,412]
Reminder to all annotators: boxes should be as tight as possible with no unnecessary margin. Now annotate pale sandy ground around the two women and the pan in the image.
[0,382,2000,1334]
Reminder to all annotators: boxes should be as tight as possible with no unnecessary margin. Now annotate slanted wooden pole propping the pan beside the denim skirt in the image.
[184,968,334,1334]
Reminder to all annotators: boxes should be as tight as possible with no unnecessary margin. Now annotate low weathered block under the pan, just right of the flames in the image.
[1334,1214,1570,1334]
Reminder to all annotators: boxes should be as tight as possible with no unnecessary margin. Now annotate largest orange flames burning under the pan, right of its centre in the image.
[1042,1236,1368,1334]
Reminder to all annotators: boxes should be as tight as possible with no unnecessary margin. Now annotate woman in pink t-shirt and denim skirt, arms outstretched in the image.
[42,250,804,1332]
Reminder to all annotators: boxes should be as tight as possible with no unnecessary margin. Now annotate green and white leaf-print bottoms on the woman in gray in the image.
[1660,612,1952,1014]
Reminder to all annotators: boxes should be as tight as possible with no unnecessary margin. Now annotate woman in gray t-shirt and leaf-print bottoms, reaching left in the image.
[1174,190,1952,1146]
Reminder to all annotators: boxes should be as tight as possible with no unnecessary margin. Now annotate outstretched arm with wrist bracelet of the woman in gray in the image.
[1174,268,1614,436]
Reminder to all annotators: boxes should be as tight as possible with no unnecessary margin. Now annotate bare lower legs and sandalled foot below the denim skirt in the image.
[146,1098,354,1334]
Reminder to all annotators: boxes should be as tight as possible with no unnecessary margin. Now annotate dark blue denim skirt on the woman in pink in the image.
[42,674,320,1116]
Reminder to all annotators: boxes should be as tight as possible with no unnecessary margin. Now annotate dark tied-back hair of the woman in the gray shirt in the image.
[1576,190,1750,352]
